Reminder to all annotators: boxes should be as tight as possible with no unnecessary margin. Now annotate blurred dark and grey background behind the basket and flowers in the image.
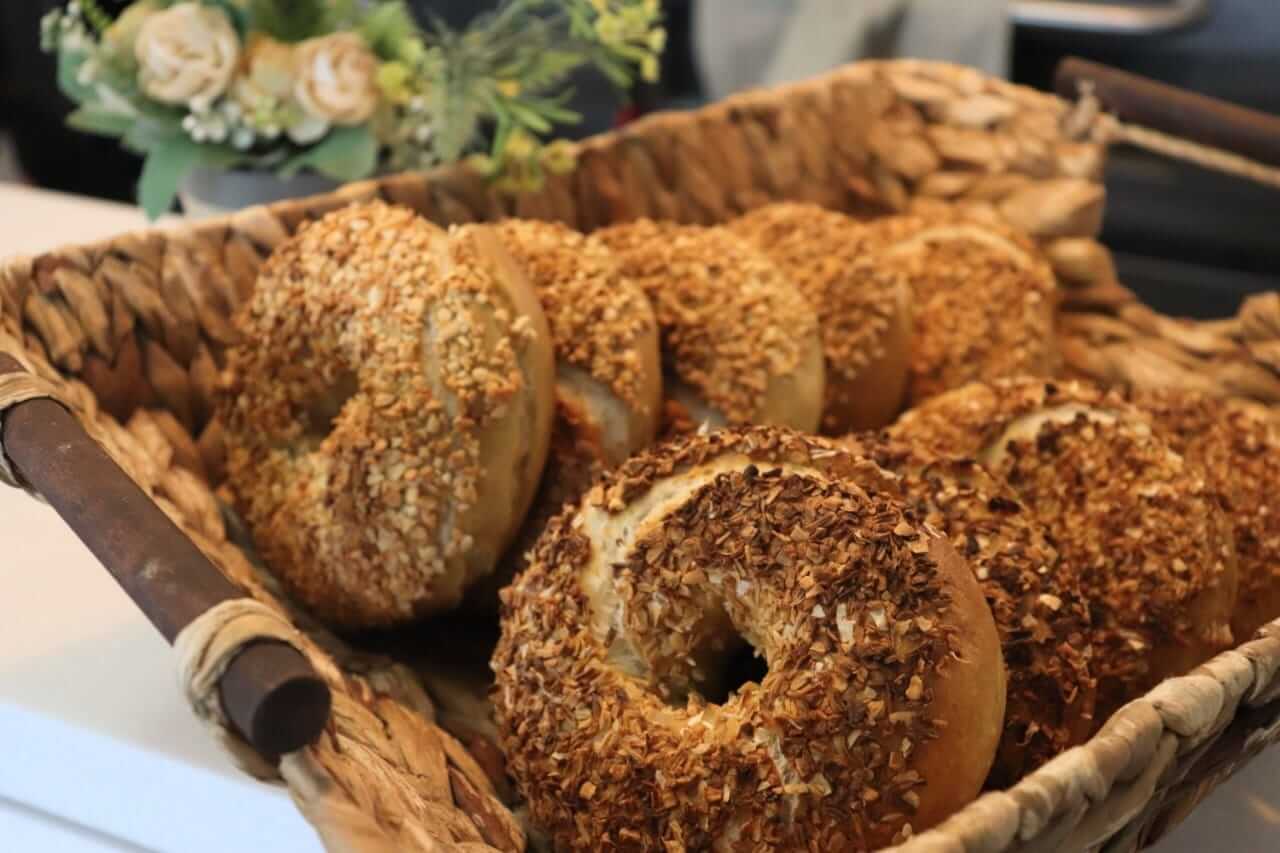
[0,0,1280,316]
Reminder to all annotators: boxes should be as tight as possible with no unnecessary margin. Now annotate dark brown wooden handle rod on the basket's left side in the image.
[0,352,332,757]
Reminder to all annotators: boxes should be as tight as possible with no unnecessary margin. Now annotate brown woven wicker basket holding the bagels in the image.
[0,61,1280,853]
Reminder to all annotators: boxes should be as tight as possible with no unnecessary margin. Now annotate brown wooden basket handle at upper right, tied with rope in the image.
[1055,56,1280,167]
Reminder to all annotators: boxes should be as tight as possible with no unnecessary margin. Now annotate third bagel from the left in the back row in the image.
[593,219,824,432]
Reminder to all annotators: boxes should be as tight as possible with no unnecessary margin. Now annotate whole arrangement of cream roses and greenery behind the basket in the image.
[42,0,666,218]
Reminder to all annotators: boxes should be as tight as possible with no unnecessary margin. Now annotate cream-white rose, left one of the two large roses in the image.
[134,3,239,111]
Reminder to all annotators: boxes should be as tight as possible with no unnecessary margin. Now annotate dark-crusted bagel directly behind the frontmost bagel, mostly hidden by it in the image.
[841,434,1097,789]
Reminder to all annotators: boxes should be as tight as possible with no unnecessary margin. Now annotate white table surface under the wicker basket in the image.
[0,183,1280,853]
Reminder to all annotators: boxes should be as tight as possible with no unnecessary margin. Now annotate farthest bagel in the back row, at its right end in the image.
[868,214,1060,403]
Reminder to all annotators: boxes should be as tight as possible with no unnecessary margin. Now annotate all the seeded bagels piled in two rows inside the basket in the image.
[218,202,1280,850]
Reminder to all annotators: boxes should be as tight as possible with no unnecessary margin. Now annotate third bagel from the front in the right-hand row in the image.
[892,379,1236,722]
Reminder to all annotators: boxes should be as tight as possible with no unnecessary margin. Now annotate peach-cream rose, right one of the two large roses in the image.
[293,32,378,124]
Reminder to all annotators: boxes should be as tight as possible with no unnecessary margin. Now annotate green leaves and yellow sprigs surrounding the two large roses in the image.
[41,0,666,216]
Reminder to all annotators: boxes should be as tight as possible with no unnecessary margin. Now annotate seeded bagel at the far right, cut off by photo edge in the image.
[1130,389,1280,643]
